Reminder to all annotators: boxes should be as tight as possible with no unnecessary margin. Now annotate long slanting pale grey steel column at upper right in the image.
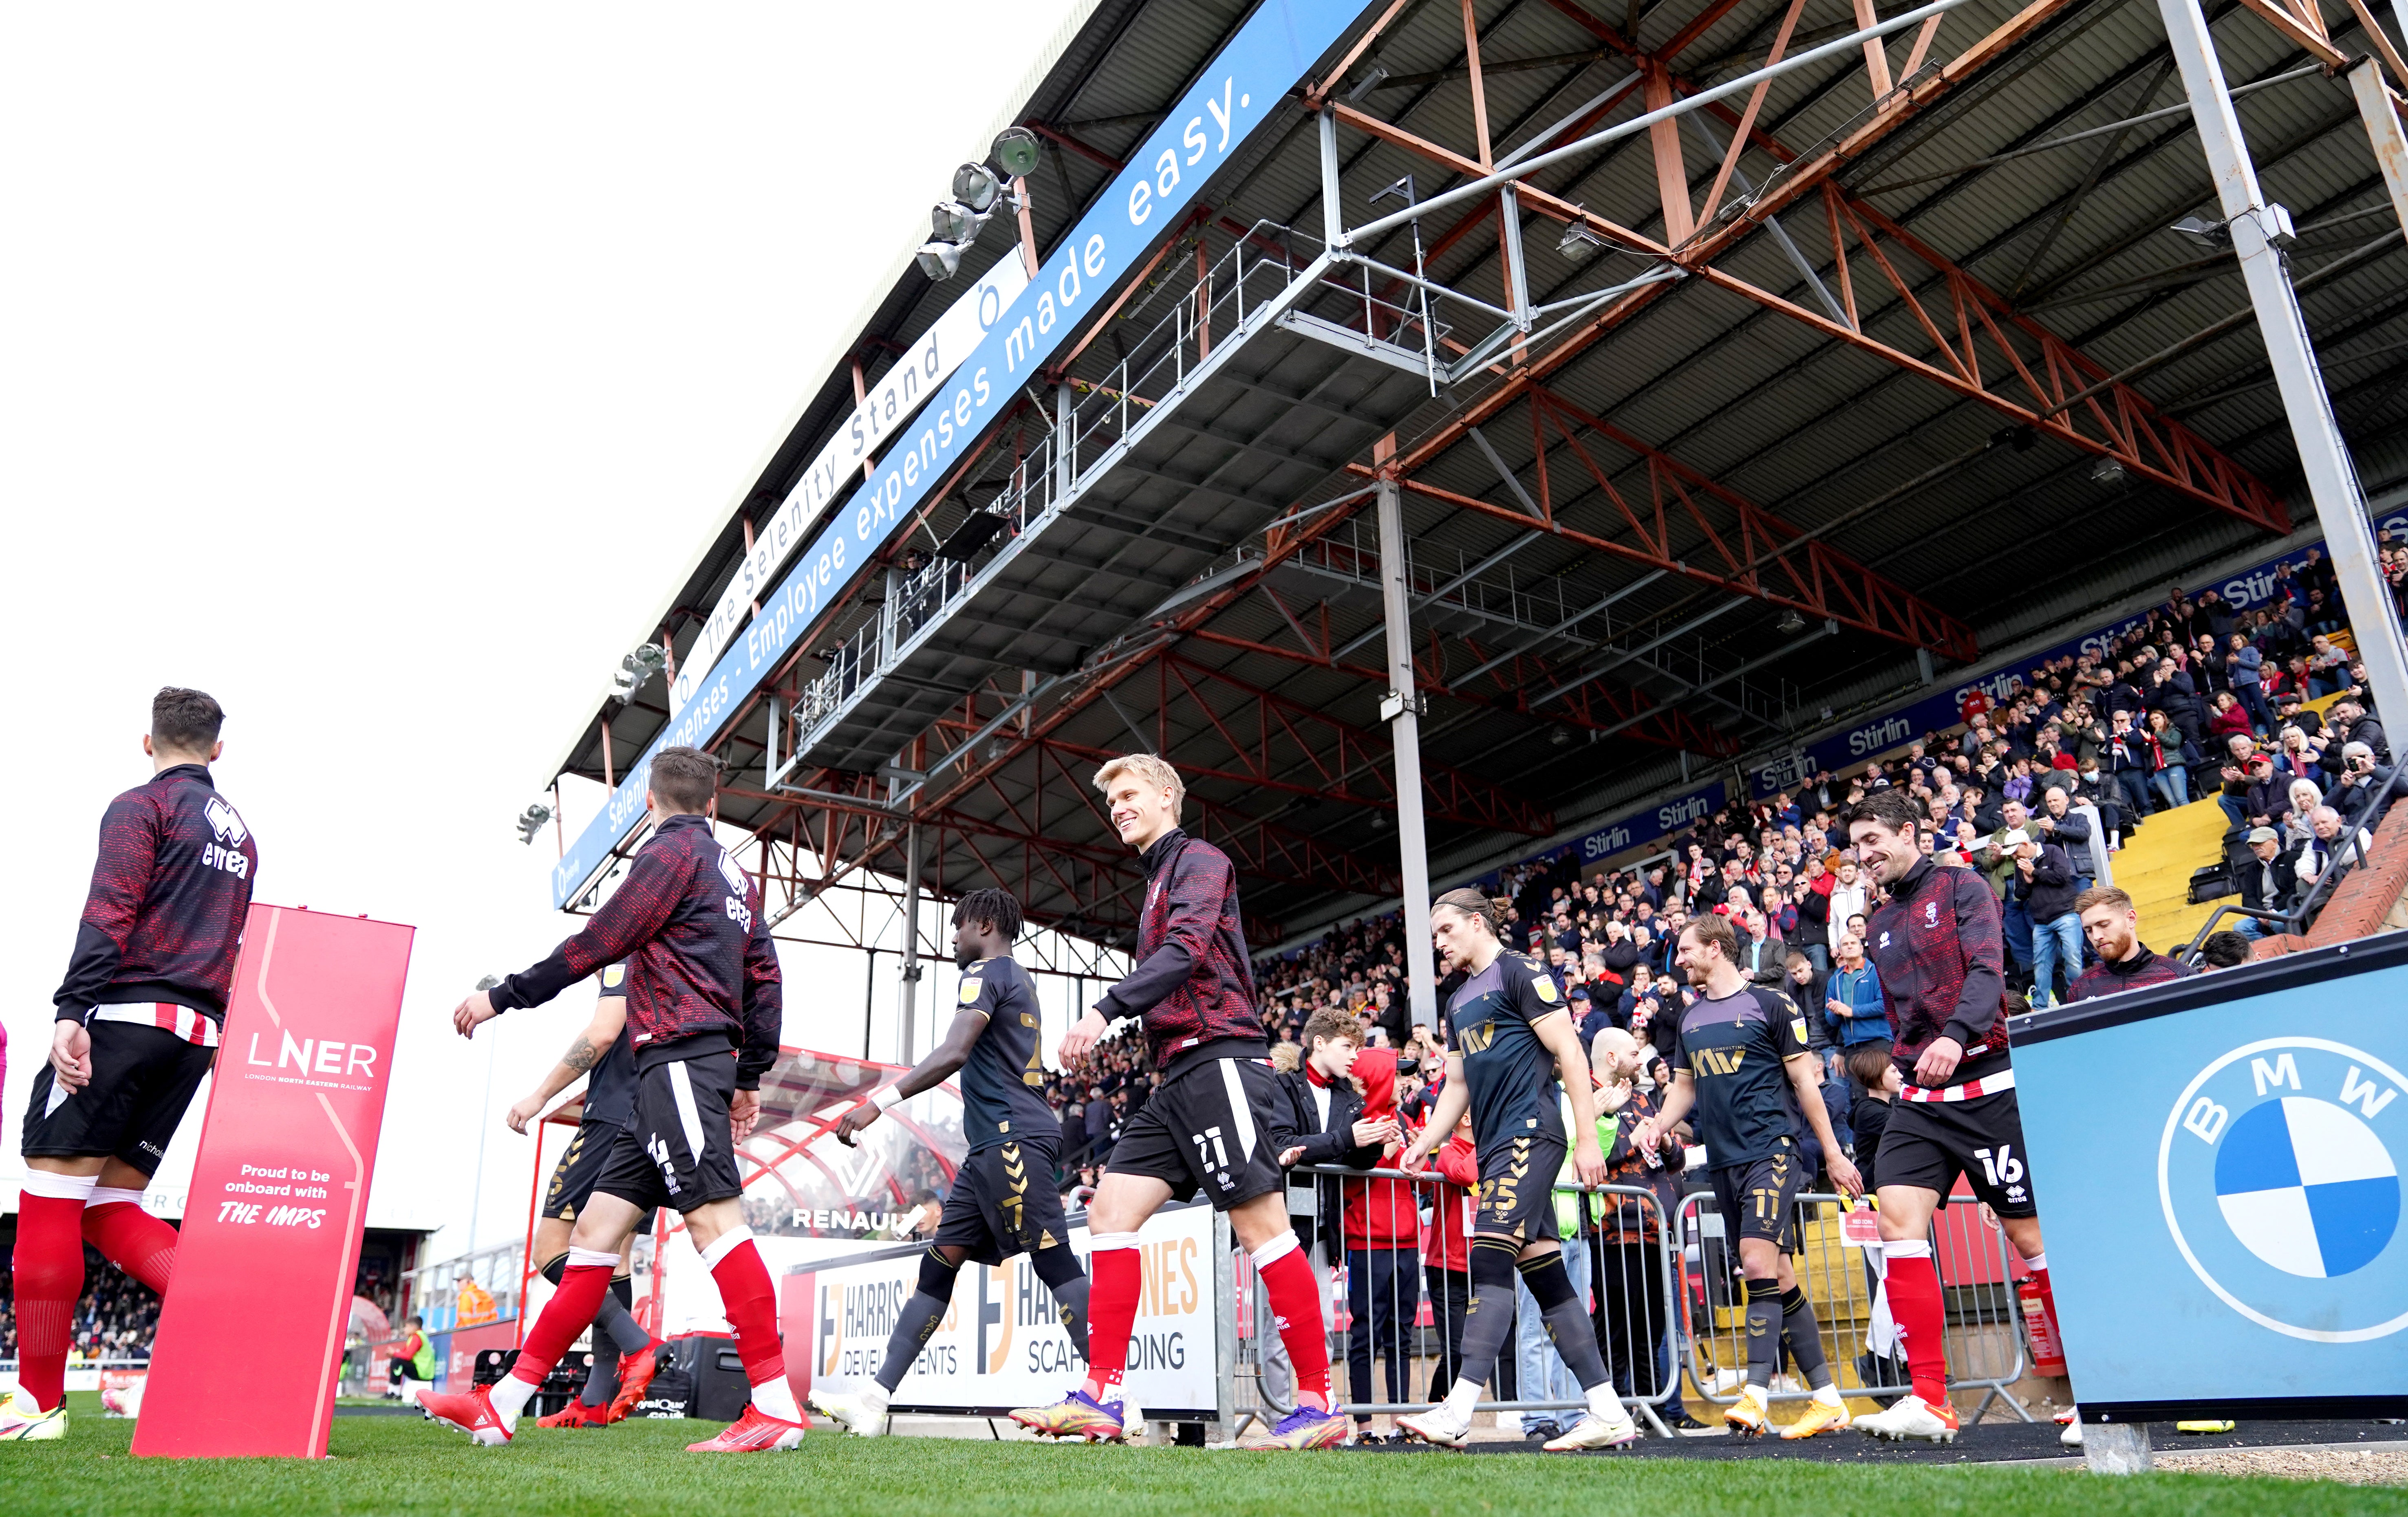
[2158,0,2408,720]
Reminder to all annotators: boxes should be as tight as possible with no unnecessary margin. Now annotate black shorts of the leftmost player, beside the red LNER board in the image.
[19,1021,217,1175]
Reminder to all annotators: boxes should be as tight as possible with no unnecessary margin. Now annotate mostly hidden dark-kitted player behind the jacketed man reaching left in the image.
[503,963,662,1428]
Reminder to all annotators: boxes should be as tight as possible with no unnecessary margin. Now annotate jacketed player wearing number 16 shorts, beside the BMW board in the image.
[1840,790,2078,1442]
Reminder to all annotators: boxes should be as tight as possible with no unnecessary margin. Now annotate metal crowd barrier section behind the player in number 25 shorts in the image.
[1221,1165,1683,1438]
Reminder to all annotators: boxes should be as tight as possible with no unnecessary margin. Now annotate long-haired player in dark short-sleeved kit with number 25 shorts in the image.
[1397,889,1640,1454]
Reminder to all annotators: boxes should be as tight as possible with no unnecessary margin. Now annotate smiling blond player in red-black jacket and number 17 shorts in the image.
[1011,754,1346,1450]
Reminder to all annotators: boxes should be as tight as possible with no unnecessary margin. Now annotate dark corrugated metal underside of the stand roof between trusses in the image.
[551,0,2408,953]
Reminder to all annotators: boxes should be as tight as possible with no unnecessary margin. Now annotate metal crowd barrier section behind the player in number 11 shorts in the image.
[1678,1189,2032,1423]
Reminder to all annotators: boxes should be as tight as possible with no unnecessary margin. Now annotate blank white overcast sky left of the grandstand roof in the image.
[0,0,1088,1257]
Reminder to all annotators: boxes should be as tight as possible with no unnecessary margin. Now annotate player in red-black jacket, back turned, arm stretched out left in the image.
[419,749,802,1454]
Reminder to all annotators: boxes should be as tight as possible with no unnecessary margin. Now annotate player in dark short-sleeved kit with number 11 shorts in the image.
[1630,918,1864,1438]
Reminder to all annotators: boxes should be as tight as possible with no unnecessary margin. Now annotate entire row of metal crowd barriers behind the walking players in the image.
[1221,1165,2032,1438]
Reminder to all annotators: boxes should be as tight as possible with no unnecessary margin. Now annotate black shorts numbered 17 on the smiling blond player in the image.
[1105,1059,1286,1211]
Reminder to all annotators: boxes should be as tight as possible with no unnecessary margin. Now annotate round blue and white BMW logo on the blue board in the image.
[2158,1038,2408,1344]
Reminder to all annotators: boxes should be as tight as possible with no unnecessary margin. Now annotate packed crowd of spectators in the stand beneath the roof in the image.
[1047,561,2408,1168]
